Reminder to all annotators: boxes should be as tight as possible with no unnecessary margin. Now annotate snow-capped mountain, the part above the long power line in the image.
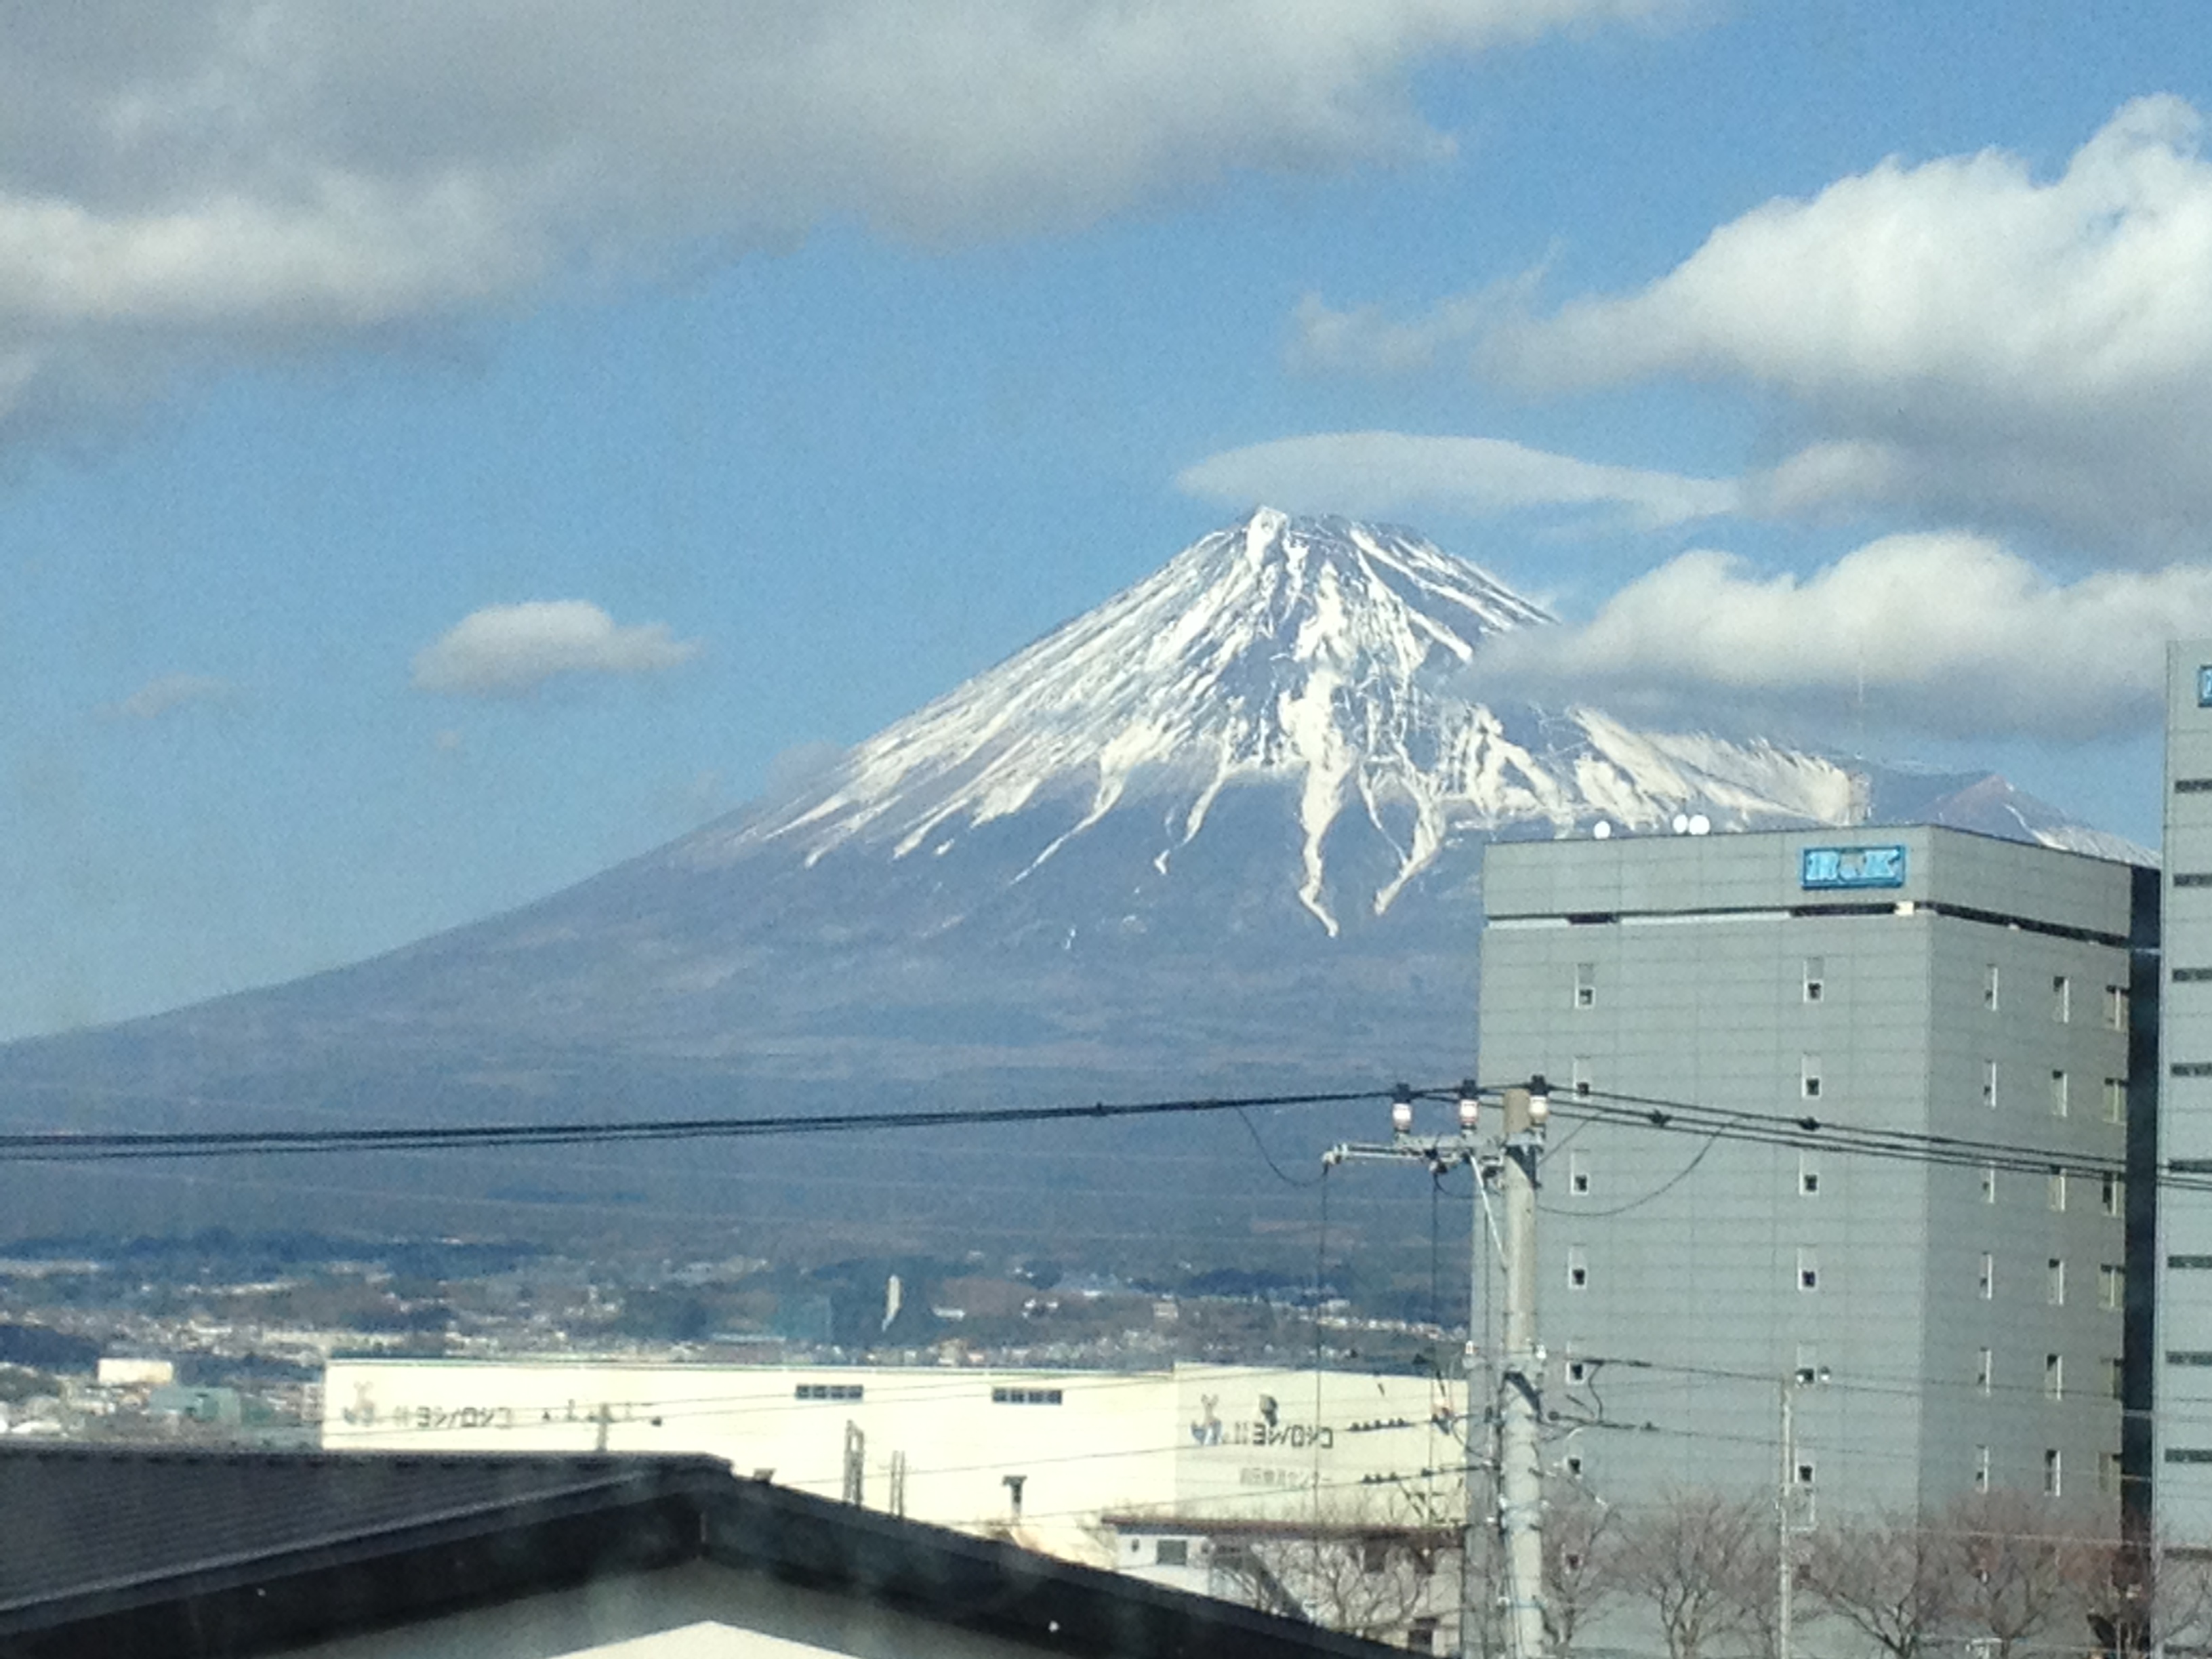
[0,509,2126,1194]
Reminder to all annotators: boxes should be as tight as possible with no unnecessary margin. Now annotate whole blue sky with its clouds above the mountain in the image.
[0,0,2212,1038]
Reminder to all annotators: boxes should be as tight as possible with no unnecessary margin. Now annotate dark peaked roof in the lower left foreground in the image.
[0,1447,1389,1659]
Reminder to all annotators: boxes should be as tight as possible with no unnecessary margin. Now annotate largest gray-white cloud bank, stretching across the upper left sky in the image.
[0,0,1685,445]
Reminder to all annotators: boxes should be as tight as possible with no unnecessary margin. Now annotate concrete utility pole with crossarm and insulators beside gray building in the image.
[1321,1078,1551,1659]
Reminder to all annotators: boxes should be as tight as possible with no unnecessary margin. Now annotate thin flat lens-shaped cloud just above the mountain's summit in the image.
[1174,431,1741,529]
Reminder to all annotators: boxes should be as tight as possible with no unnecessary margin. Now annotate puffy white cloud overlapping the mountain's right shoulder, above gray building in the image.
[1482,533,2212,739]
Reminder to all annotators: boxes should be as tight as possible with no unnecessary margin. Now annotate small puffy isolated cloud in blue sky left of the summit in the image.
[413,600,699,697]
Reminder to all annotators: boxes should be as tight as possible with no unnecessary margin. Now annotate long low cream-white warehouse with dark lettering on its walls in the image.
[323,1358,1467,1566]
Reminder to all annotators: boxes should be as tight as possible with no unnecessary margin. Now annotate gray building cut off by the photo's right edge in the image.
[2146,639,2212,1549]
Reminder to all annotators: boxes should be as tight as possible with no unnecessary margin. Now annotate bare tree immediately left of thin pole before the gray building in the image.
[1612,1493,1767,1659]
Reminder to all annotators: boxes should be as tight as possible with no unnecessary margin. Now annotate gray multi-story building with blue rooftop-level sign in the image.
[1480,832,2132,1524]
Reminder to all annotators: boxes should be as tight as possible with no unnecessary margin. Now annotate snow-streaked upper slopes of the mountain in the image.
[684,509,1893,936]
